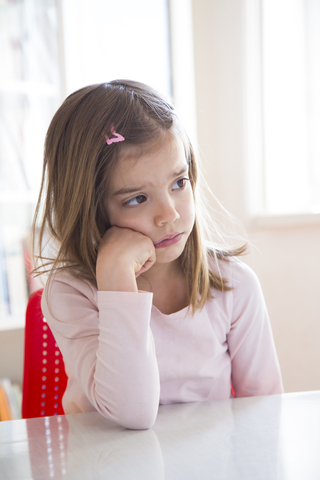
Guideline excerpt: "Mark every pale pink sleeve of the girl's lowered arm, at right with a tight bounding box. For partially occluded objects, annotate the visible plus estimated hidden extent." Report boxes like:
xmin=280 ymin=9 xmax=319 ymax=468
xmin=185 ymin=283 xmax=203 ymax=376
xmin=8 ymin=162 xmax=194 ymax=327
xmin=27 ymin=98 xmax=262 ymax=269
xmin=227 ymin=262 xmax=283 ymax=397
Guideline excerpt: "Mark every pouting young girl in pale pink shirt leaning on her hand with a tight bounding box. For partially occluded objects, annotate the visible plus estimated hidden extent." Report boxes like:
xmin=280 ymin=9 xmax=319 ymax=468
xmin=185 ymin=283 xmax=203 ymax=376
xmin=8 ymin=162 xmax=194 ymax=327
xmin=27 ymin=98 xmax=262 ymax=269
xmin=34 ymin=80 xmax=283 ymax=429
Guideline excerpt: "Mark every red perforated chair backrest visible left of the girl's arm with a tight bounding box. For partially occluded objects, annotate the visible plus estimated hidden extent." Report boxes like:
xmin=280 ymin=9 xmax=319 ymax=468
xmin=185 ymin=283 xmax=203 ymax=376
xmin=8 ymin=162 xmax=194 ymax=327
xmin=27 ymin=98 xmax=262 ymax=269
xmin=22 ymin=289 xmax=67 ymax=418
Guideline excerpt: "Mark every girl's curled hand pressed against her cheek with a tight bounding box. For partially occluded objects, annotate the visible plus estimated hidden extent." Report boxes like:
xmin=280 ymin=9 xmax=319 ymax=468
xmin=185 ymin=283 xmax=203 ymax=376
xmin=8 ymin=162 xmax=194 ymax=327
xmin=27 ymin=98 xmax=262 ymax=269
xmin=96 ymin=226 xmax=156 ymax=292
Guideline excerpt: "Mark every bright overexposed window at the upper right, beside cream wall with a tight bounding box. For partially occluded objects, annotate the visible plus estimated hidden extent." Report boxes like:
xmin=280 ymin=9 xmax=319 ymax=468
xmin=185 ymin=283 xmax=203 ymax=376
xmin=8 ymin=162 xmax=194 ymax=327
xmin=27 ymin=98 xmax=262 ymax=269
xmin=247 ymin=0 xmax=320 ymax=215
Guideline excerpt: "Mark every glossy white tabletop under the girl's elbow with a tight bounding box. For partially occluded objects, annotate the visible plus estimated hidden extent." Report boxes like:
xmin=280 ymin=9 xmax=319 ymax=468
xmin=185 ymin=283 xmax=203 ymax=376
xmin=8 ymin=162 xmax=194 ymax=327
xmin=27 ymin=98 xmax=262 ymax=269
xmin=0 ymin=391 xmax=320 ymax=480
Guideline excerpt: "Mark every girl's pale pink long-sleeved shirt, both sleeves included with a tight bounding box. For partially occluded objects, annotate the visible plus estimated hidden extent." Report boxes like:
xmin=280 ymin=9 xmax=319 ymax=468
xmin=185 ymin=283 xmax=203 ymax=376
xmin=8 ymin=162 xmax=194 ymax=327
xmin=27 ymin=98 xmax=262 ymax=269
xmin=42 ymin=260 xmax=283 ymax=428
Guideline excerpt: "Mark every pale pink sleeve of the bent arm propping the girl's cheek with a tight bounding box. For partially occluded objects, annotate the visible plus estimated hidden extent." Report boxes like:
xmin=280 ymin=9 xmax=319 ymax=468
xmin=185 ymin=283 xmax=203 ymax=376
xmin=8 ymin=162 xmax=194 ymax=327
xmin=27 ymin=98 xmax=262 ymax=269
xmin=42 ymin=272 xmax=160 ymax=429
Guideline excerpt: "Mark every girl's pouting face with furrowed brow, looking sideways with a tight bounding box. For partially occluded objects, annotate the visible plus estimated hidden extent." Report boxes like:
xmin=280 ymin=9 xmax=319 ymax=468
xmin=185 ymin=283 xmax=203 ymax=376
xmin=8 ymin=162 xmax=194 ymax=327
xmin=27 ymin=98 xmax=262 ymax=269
xmin=107 ymin=137 xmax=195 ymax=264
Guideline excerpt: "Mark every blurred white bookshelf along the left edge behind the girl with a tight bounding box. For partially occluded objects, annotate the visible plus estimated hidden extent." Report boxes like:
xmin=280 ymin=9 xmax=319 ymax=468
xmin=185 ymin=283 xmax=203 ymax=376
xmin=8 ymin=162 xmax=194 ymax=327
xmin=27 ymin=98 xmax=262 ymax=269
xmin=0 ymin=0 xmax=62 ymax=333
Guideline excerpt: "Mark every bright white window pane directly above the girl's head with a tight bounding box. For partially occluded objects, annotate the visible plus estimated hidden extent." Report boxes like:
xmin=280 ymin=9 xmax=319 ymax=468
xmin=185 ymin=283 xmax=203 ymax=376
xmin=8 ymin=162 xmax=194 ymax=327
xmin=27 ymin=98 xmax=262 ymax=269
xmin=61 ymin=0 xmax=171 ymax=96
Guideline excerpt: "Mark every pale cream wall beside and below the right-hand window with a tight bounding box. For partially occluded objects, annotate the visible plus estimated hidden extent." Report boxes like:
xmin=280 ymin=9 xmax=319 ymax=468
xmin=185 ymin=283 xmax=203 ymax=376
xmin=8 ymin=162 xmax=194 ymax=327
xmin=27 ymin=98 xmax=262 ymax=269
xmin=193 ymin=0 xmax=320 ymax=392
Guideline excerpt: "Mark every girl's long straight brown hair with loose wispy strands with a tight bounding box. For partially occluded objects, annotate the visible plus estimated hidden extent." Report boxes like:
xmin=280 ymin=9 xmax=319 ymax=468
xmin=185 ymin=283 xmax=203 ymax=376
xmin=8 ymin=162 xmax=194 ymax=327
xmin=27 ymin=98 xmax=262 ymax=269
xmin=33 ymin=80 xmax=245 ymax=312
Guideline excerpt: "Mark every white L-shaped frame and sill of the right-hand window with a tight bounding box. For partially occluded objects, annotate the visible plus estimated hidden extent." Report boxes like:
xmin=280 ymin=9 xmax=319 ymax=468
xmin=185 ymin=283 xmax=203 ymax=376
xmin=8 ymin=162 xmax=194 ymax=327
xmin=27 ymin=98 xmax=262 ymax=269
xmin=243 ymin=0 xmax=320 ymax=227
